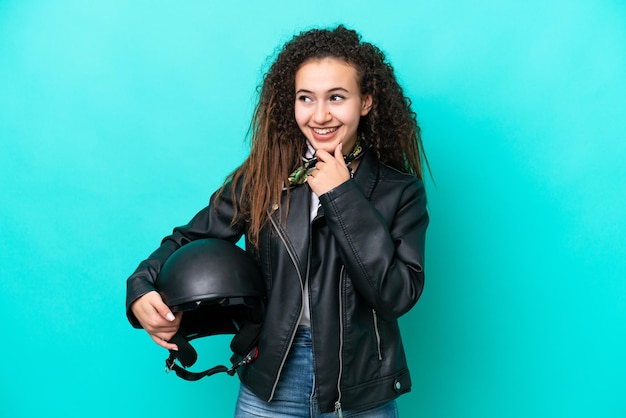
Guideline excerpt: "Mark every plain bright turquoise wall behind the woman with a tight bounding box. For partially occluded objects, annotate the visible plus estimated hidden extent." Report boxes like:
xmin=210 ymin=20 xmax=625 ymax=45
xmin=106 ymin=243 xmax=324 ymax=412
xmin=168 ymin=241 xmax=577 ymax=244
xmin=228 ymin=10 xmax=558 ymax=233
xmin=0 ymin=0 xmax=626 ymax=418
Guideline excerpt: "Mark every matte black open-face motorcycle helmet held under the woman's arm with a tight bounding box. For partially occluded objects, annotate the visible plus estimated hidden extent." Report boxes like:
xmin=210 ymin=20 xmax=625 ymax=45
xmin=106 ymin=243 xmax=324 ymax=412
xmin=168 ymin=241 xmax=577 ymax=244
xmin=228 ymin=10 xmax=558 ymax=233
xmin=155 ymin=238 xmax=265 ymax=380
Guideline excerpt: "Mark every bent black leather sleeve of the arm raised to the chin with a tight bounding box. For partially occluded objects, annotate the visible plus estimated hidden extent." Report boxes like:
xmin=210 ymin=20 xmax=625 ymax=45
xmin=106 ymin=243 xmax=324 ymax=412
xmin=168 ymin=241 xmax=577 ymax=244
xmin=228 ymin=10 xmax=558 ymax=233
xmin=320 ymin=173 xmax=429 ymax=319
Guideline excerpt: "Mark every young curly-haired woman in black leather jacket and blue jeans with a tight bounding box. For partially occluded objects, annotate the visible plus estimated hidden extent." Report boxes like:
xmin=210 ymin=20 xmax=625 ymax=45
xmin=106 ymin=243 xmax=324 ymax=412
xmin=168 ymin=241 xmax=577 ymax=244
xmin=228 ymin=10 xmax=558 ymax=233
xmin=127 ymin=26 xmax=428 ymax=417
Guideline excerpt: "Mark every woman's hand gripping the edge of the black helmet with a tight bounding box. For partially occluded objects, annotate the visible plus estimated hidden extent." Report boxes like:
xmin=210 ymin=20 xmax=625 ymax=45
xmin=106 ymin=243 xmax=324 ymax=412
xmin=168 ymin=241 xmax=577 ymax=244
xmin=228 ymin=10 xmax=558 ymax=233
xmin=130 ymin=290 xmax=183 ymax=350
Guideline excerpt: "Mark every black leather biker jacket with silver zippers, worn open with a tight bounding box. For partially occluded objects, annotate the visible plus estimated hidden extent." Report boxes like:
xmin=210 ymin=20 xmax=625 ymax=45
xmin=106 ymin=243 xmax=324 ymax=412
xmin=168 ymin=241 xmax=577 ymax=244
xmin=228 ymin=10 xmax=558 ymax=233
xmin=126 ymin=151 xmax=429 ymax=412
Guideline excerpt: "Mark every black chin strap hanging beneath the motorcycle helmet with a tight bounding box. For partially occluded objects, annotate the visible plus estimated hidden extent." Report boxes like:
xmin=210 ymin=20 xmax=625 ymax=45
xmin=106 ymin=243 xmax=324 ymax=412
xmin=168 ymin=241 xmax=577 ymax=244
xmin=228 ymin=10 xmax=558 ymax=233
xmin=165 ymin=323 xmax=261 ymax=381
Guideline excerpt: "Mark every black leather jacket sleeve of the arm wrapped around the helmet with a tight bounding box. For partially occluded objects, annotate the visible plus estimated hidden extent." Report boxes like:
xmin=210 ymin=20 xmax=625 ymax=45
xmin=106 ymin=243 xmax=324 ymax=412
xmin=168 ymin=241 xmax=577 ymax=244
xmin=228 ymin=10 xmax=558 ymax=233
xmin=126 ymin=186 xmax=244 ymax=328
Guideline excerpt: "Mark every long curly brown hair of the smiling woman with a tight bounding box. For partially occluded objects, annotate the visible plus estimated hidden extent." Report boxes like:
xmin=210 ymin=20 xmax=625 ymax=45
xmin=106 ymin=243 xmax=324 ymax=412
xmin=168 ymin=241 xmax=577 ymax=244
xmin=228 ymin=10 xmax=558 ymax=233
xmin=218 ymin=25 xmax=426 ymax=246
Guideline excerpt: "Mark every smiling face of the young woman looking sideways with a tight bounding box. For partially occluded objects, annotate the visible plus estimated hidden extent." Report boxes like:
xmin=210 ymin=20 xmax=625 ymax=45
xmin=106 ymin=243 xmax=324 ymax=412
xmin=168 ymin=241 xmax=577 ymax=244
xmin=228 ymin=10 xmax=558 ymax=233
xmin=295 ymin=58 xmax=372 ymax=154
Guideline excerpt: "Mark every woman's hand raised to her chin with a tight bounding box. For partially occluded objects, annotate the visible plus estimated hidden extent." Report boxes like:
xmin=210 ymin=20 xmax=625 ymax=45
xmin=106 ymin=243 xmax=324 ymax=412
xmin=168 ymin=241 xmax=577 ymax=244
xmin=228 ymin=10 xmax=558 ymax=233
xmin=306 ymin=143 xmax=350 ymax=196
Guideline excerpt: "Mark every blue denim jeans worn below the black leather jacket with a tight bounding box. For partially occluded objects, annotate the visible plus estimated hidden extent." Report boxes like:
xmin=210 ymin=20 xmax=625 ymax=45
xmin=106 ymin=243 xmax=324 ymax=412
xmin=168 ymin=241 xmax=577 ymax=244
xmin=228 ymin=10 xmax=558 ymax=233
xmin=235 ymin=328 xmax=398 ymax=418
